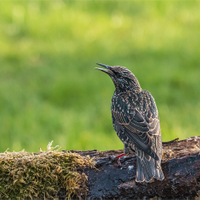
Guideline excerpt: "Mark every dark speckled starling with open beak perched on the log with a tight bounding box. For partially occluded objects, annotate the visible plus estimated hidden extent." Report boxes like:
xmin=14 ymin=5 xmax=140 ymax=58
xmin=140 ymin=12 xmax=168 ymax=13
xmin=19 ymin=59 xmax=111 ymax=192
xmin=95 ymin=63 xmax=164 ymax=182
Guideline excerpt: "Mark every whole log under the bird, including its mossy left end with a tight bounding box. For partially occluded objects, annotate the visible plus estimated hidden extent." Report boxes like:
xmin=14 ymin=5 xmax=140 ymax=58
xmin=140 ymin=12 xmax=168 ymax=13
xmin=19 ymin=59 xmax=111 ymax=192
xmin=0 ymin=136 xmax=200 ymax=199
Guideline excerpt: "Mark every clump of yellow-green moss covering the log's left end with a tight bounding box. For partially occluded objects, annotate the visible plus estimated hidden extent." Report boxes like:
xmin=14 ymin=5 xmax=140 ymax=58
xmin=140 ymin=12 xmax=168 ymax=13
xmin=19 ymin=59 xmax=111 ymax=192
xmin=0 ymin=145 xmax=94 ymax=199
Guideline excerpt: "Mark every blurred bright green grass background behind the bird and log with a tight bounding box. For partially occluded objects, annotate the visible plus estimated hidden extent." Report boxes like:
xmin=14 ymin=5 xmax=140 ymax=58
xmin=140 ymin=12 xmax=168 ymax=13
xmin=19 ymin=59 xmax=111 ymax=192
xmin=0 ymin=0 xmax=200 ymax=152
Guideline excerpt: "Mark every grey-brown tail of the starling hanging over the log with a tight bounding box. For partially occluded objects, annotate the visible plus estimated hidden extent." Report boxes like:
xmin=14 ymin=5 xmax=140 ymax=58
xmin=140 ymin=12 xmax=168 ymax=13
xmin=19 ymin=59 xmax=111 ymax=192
xmin=136 ymin=150 xmax=164 ymax=182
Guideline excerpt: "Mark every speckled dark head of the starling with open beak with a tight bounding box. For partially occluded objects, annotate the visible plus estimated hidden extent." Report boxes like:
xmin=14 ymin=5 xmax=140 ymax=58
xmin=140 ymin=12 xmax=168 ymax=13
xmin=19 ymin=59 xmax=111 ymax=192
xmin=95 ymin=63 xmax=142 ymax=92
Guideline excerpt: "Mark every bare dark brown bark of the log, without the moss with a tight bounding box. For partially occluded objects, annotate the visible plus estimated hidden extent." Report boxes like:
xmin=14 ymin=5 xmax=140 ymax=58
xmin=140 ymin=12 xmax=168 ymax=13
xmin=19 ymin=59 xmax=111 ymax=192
xmin=68 ymin=136 xmax=200 ymax=199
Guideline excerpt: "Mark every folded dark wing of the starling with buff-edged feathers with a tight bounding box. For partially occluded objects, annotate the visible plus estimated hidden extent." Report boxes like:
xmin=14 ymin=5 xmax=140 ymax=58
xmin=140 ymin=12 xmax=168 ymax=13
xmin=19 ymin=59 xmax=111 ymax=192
xmin=112 ymin=92 xmax=159 ymax=157
